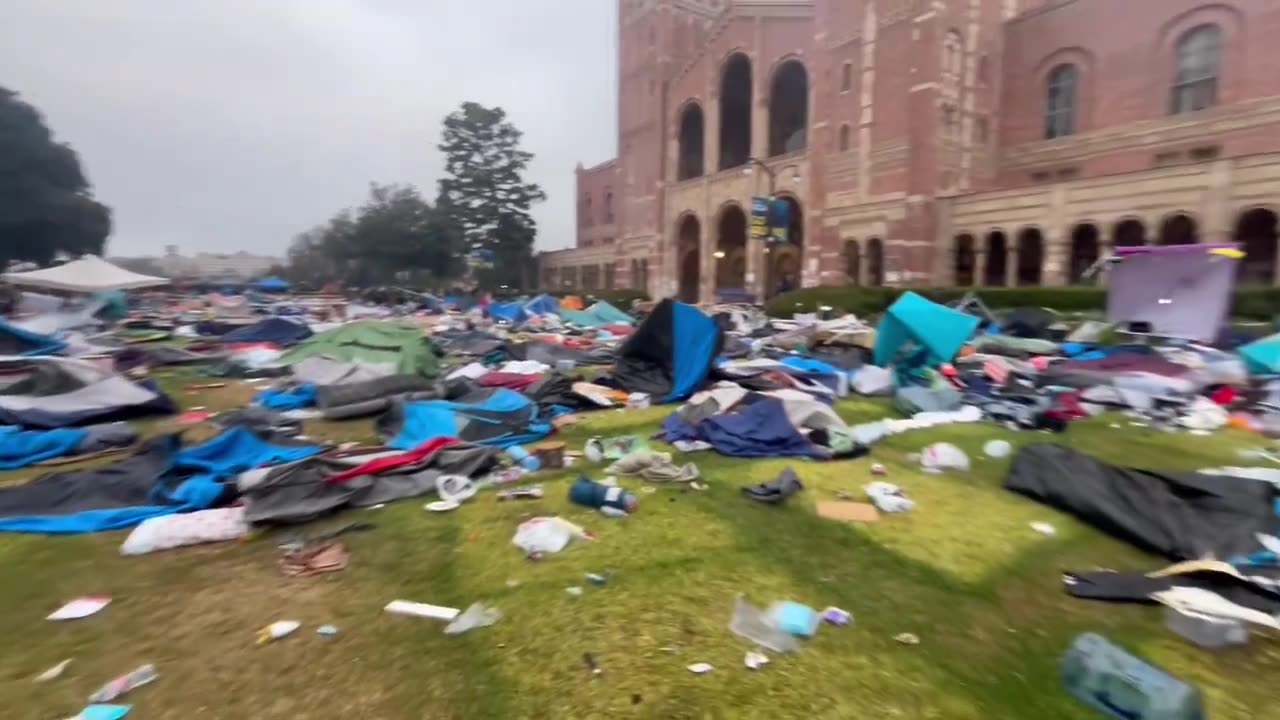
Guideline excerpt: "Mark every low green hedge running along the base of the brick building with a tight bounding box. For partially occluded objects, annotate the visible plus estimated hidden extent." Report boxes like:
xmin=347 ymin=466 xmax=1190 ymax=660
xmin=765 ymin=287 xmax=1280 ymax=320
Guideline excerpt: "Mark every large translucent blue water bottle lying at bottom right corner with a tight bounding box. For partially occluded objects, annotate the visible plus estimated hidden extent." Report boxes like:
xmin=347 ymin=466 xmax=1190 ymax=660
xmin=1060 ymin=633 xmax=1204 ymax=720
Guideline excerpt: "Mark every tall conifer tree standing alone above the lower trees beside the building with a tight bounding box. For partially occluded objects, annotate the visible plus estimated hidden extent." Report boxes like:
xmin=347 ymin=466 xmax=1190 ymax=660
xmin=436 ymin=102 xmax=547 ymax=287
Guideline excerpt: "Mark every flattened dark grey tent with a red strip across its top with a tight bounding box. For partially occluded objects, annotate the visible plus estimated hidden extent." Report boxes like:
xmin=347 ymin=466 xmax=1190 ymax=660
xmin=238 ymin=438 xmax=499 ymax=524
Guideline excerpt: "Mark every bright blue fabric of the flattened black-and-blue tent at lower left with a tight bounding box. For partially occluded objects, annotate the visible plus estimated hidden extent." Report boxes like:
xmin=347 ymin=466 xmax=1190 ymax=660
xmin=0 ymin=428 xmax=324 ymax=534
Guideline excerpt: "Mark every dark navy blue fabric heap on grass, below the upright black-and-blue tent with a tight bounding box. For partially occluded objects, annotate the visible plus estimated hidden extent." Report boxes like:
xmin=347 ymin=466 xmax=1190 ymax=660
xmin=662 ymin=397 xmax=826 ymax=459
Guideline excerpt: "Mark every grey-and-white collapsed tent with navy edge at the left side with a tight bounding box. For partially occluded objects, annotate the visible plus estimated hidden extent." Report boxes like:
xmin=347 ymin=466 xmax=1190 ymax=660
xmin=0 ymin=356 xmax=177 ymax=428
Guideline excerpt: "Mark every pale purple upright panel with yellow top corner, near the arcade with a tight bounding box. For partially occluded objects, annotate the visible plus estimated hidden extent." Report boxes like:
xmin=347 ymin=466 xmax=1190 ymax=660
xmin=1107 ymin=245 xmax=1239 ymax=341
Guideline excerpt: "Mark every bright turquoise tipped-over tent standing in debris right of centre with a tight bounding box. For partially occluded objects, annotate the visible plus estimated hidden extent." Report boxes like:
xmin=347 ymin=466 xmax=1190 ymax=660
xmin=874 ymin=292 xmax=982 ymax=368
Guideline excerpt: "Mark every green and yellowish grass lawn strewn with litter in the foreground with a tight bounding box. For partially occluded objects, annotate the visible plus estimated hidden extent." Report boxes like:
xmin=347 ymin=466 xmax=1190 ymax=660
xmin=0 ymin=378 xmax=1280 ymax=720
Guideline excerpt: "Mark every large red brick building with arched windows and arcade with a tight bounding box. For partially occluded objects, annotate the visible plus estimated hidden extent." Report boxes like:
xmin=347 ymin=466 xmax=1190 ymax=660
xmin=541 ymin=0 xmax=1280 ymax=300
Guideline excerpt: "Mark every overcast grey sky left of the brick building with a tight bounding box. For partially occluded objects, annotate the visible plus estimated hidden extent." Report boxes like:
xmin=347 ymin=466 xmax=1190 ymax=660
xmin=0 ymin=0 xmax=617 ymax=255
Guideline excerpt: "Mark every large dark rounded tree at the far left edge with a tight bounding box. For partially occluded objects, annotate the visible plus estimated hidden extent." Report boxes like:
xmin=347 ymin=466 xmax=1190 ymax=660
xmin=0 ymin=87 xmax=111 ymax=268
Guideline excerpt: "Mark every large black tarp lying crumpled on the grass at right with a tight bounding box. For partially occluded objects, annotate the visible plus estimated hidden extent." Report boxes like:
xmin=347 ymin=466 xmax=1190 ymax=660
xmin=1005 ymin=445 xmax=1280 ymax=560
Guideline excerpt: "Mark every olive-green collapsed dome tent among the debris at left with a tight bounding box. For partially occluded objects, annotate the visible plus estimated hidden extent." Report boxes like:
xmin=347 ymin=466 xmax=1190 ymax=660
xmin=280 ymin=320 xmax=440 ymax=378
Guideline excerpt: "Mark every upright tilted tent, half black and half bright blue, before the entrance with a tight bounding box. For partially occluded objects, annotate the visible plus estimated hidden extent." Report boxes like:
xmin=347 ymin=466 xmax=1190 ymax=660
xmin=613 ymin=299 xmax=724 ymax=402
